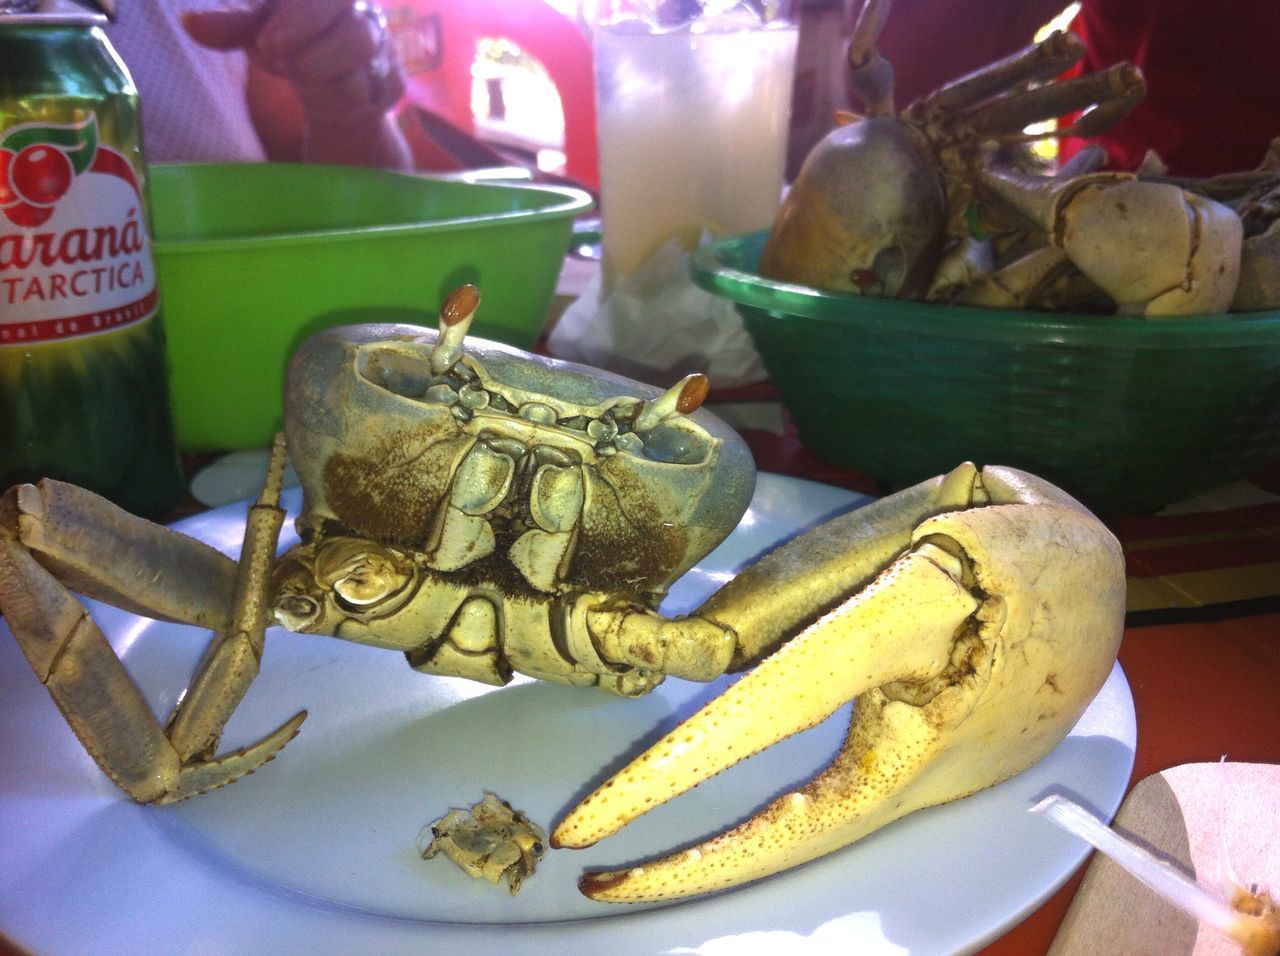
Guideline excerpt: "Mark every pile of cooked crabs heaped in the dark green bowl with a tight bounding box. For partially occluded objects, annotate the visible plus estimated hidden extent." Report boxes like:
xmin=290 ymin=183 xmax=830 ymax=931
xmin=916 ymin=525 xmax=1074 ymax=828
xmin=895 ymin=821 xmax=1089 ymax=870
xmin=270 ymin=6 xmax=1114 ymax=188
xmin=760 ymin=0 xmax=1280 ymax=316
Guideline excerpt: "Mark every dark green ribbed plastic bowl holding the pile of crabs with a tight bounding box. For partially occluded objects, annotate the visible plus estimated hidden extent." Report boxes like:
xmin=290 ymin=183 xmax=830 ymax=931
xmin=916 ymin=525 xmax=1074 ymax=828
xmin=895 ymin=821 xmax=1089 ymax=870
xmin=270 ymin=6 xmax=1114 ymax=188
xmin=694 ymin=233 xmax=1280 ymax=512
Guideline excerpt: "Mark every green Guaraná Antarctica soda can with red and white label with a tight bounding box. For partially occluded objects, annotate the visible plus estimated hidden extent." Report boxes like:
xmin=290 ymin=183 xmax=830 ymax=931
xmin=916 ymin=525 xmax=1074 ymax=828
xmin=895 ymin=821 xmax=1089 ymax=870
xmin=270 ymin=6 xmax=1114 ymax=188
xmin=0 ymin=0 xmax=183 ymax=517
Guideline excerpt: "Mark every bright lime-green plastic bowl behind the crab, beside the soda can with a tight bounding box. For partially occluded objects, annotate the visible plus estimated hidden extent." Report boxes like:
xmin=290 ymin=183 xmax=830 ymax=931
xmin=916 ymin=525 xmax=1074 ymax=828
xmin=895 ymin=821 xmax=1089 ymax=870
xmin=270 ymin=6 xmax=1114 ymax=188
xmin=150 ymin=164 xmax=591 ymax=450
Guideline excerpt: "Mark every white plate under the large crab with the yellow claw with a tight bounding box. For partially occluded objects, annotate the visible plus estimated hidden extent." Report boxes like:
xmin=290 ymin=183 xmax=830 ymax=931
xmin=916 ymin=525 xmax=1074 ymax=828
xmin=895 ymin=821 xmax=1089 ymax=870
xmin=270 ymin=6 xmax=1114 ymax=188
xmin=0 ymin=475 xmax=1135 ymax=956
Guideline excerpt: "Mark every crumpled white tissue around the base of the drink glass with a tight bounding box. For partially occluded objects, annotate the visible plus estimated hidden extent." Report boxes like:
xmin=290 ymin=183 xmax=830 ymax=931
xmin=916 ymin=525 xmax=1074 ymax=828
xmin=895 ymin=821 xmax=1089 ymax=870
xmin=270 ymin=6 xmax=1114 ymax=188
xmin=548 ymin=239 xmax=768 ymax=388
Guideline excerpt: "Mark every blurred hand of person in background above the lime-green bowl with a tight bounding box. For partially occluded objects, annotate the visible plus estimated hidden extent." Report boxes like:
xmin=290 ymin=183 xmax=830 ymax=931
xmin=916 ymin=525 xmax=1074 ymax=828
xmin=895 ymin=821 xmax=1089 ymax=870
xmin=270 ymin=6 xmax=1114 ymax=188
xmin=182 ymin=0 xmax=404 ymax=120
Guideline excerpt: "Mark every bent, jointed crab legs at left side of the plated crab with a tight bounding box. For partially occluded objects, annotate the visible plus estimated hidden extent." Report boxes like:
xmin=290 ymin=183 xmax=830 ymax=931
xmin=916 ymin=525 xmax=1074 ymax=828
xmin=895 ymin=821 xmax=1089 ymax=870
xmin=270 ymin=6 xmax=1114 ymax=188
xmin=0 ymin=437 xmax=305 ymax=802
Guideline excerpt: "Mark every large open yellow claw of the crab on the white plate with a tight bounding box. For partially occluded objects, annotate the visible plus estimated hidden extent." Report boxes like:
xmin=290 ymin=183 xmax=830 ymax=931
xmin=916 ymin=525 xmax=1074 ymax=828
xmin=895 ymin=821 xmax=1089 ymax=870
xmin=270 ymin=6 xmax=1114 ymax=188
xmin=552 ymin=465 xmax=1125 ymax=902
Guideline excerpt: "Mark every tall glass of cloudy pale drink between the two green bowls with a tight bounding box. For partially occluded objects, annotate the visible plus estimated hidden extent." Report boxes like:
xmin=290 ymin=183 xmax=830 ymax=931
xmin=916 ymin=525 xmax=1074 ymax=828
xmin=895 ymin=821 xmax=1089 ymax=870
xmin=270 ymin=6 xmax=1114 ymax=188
xmin=595 ymin=20 xmax=796 ymax=293
